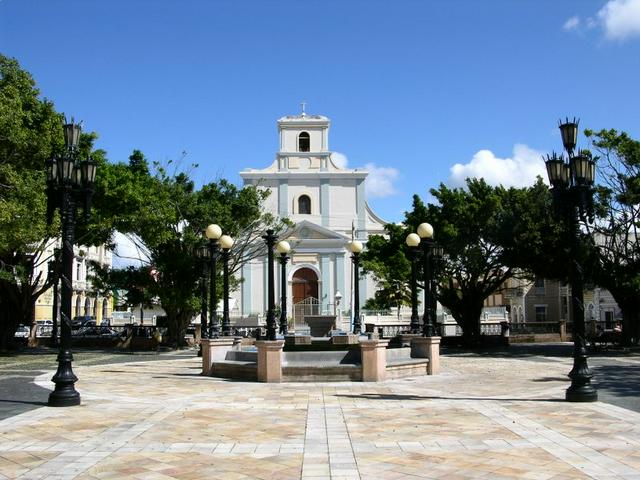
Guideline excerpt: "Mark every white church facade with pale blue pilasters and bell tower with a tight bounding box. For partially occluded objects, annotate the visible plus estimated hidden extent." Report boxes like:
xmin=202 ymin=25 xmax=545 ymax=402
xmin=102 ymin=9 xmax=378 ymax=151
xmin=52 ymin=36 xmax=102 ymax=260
xmin=234 ymin=110 xmax=385 ymax=324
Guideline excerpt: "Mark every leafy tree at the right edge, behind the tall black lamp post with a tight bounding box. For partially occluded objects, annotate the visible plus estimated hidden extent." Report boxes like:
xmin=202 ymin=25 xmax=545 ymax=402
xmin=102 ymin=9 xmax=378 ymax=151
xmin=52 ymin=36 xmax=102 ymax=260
xmin=585 ymin=130 xmax=640 ymax=344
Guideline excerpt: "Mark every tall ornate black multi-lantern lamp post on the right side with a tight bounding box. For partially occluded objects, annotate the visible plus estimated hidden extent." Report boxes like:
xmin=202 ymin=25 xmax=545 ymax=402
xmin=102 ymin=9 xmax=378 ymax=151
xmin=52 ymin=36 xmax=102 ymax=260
xmin=545 ymin=119 xmax=598 ymax=402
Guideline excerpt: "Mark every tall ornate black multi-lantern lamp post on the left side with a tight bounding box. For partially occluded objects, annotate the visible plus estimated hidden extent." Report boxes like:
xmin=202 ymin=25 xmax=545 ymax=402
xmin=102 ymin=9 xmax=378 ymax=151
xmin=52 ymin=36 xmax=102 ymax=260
xmin=47 ymin=122 xmax=96 ymax=407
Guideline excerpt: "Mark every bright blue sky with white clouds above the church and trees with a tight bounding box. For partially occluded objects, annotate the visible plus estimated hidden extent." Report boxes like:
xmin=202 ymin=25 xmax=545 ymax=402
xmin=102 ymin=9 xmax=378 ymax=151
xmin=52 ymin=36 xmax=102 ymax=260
xmin=0 ymin=0 xmax=640 ymax=221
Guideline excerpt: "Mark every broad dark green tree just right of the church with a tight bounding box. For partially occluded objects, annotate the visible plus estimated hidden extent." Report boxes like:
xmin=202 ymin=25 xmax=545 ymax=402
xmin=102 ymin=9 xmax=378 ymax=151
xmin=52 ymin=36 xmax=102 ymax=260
xmin=363 ymin=179 xmax=558 ymax=343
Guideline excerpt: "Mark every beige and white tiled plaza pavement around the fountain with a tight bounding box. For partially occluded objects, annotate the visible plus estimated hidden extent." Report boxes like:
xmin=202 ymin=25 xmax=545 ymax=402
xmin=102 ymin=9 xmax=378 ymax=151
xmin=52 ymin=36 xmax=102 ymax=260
xmin=0 ymin=346 xmax=640 ymax=480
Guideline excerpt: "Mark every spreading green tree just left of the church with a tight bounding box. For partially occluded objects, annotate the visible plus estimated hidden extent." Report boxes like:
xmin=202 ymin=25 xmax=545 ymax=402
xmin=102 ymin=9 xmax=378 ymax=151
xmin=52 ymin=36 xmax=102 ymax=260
xmin=89 ymin=151 xmax=283 ymax=346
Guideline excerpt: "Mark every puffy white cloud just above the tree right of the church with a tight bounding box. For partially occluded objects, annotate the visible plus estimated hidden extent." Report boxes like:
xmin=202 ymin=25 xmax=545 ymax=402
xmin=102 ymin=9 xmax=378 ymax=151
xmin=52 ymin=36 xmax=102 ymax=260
xmin=449 ymin=144 xmax=547 ymax=187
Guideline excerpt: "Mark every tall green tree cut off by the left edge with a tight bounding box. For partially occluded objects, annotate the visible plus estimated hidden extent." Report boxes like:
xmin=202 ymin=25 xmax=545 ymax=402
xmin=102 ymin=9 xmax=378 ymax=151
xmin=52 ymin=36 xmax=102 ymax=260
xmin=0 ymin=55 xmax=64 ymax=350
